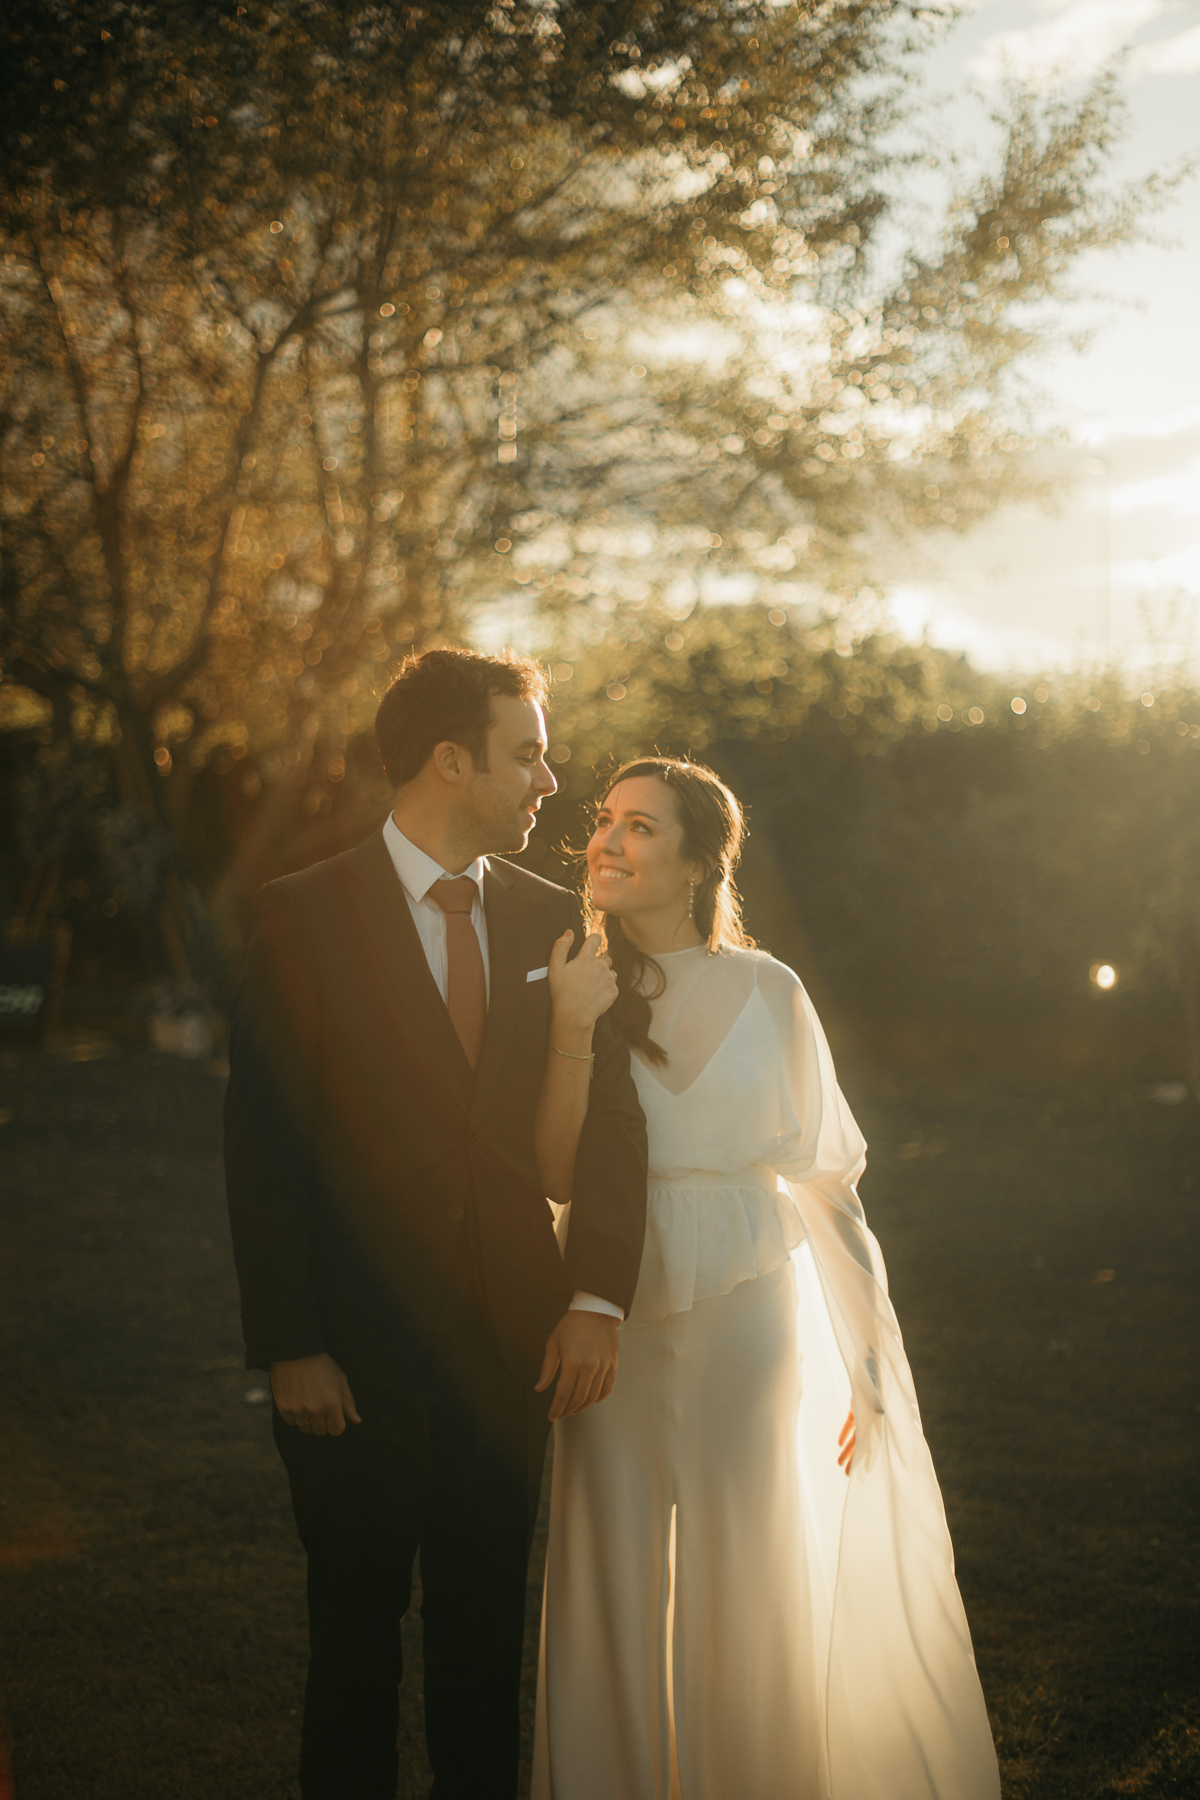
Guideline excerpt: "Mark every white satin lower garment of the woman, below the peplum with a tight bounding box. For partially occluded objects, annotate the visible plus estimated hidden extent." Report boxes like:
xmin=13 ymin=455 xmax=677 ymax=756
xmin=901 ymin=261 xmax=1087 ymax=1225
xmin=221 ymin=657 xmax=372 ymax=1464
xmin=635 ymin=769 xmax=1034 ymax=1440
xmin=533 ymin=1262 xmax=837 ymax=1800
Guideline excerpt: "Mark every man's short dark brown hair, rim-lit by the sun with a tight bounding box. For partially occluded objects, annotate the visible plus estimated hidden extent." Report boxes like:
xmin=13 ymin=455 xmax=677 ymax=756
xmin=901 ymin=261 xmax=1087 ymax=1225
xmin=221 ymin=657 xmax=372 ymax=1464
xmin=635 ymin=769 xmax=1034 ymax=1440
xmin=374 ymin=650 xmax=547 ymax=787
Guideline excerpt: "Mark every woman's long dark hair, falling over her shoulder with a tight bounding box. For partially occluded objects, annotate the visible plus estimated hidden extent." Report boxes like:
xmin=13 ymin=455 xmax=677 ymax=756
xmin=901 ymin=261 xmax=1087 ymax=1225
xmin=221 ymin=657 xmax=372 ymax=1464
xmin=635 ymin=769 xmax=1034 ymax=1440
xmin=588 ymin=756 xmax=754 ymax=1064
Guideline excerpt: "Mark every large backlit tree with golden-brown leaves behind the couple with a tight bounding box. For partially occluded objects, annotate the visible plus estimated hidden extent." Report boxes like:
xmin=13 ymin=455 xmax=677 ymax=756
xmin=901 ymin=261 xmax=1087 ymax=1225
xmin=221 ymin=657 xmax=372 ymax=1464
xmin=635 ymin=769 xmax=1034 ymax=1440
xmin=0 ymin=0 xmax=1153 ymax=957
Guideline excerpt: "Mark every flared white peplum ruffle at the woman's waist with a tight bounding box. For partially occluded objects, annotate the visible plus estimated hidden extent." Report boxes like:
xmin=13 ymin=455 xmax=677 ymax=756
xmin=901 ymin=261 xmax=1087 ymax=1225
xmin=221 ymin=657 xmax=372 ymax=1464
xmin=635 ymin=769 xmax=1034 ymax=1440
xmin=630 ymin=1168 xmax=804 ymax=1325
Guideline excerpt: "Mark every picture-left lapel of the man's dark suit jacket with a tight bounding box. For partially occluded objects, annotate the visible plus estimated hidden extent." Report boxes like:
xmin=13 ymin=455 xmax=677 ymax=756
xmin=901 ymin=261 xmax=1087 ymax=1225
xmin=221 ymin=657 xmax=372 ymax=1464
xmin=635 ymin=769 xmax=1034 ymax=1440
xmin=341 ymin=832 xmax=474 ymax=1107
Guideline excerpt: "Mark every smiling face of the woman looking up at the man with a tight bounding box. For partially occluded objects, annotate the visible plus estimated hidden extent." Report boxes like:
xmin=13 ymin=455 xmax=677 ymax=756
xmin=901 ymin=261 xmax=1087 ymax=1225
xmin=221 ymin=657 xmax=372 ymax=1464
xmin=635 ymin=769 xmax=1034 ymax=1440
xmin=588 ymin=776 xmax=698 ymax=918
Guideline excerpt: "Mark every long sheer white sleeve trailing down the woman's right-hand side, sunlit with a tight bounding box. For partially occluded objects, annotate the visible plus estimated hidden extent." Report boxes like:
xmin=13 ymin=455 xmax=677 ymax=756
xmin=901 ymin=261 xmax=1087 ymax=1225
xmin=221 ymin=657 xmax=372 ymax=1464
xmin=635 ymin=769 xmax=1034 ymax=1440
xmin=763 ymin=963 xmax=1000 ymax=1800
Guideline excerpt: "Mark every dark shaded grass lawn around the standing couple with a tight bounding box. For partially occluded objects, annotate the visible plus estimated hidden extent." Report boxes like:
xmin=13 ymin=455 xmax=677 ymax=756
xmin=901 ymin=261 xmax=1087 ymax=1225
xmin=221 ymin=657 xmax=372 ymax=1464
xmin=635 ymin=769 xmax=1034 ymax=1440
xmin=0 ymin=1051 xmax=1200 ymax=1800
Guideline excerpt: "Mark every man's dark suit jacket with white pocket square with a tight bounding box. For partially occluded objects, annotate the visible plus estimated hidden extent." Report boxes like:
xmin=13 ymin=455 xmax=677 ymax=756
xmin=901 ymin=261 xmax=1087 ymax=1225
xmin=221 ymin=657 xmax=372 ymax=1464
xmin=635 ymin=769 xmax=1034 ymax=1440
xmin=225 ymin=832 xmax=646 ymax=1386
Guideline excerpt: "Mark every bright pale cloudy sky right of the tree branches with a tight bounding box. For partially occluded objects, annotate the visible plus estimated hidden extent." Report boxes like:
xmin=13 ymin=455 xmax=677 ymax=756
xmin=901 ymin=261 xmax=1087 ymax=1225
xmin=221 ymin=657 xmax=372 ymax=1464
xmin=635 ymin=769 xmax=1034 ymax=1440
xmin=889 ymin=0 xmax=1200 ymax=673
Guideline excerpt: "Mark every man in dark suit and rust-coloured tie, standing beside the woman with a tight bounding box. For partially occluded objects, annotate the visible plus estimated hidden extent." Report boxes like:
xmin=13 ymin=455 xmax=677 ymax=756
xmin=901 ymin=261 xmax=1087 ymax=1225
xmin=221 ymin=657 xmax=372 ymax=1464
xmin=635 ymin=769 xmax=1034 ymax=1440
xmin=225 ymin=650 xmax=646 ymax=1800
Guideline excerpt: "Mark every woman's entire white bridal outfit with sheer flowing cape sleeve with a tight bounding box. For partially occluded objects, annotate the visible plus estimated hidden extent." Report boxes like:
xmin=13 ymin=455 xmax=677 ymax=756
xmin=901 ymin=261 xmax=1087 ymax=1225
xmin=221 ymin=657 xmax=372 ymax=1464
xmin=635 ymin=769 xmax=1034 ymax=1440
xmin=533 ymin=947 xmax=1000 ymax=1800
